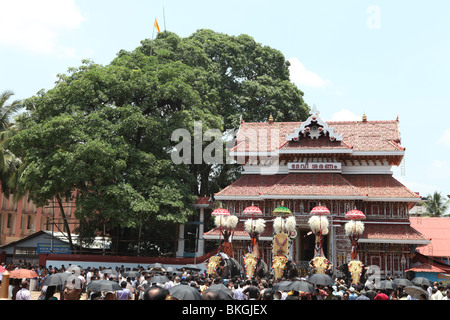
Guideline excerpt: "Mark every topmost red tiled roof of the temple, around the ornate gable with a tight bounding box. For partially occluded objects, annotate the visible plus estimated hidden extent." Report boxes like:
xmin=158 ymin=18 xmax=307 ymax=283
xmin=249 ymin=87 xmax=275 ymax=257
xmin=231 ymin=120 xmax=404 ymax=152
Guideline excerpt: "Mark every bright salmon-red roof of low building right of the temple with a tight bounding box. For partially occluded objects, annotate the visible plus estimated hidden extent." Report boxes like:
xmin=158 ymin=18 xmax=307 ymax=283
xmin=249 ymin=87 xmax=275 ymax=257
xmin=409 ymin=217 xmax=450 ymax=257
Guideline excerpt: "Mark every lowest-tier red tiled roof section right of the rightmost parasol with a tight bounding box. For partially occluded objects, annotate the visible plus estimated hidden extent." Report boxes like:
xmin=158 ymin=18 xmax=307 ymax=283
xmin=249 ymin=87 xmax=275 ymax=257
xmin=359 ymin=223 xmax=427 ymax=244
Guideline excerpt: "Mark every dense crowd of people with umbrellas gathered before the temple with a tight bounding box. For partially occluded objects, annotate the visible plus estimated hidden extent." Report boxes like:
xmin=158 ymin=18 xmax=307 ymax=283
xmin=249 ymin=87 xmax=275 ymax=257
xmin=4 ymin=265 xmax=450 ymax=300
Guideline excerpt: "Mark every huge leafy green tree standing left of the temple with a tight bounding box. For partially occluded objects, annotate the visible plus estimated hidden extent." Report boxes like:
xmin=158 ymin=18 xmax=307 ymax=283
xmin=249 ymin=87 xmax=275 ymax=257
xmin=10 ymin=30 xmax=308 ymax=253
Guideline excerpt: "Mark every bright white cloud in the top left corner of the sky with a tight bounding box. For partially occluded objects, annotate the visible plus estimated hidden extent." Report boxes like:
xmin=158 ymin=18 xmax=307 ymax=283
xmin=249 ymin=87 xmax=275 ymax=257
xmin=0 ymin=0 xmax=85 ymax=57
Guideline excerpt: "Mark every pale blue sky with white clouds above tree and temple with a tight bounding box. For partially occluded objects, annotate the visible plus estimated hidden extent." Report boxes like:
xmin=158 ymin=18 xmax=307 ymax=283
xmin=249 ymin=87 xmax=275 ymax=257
xmin=0 ymin=0 xmax=450 ymax=196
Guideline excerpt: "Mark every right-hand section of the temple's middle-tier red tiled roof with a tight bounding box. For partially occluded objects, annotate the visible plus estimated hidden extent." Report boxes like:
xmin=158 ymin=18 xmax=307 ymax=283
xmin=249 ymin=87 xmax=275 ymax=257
xmin=344 ymin=174 xmax=420 ymax=198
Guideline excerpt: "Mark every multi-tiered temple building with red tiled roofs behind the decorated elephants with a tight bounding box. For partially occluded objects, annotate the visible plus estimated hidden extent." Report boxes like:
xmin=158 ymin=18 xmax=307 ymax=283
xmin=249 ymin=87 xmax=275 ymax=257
xmin=204 ymin=107 xmax=430 ymax=276
